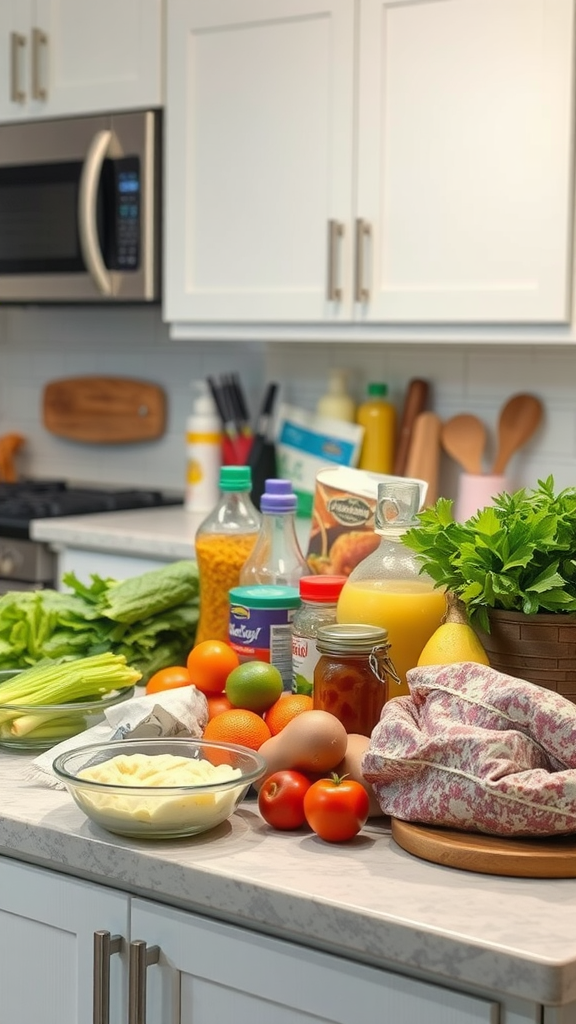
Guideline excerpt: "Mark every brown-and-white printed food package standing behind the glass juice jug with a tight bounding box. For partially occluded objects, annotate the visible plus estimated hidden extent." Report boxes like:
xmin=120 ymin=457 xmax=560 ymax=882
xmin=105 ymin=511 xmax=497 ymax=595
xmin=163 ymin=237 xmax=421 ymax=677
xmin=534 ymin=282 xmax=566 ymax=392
xmin=306 ymin=467 xmax=426 ymax=575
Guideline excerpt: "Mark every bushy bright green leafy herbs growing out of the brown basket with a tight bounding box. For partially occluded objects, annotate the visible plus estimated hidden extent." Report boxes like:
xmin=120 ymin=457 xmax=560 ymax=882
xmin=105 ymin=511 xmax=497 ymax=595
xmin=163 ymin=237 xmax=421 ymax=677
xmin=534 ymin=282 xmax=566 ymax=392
xmin=402 ymin=476 xmax=576 ymax=632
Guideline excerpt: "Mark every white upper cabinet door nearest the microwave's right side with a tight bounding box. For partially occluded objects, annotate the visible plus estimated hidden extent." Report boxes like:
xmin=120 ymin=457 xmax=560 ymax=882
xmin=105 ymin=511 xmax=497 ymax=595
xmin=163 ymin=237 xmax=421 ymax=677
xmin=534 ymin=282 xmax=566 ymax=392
xmin=164 ymin=0 xmax=355 ymax=322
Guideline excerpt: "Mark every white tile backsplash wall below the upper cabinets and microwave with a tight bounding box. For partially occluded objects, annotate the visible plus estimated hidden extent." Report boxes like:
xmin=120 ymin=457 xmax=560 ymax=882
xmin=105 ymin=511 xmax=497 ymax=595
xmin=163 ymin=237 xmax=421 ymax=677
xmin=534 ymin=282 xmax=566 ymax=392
xmin=0 ymin=306 xmax=576 ymax=497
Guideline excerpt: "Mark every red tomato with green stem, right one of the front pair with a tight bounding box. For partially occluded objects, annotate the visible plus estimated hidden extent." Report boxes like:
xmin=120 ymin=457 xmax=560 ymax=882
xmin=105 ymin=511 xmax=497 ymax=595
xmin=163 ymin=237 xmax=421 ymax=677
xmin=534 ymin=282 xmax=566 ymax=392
xmin=304 ymin=774 xmax=370 ymax=843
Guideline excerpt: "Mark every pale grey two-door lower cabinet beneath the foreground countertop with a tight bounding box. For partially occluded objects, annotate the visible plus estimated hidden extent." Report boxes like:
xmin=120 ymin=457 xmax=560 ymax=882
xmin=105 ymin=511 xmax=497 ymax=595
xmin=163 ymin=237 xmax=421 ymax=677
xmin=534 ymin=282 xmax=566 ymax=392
xmin=0 ymin=858 xmax=502 ymax=1024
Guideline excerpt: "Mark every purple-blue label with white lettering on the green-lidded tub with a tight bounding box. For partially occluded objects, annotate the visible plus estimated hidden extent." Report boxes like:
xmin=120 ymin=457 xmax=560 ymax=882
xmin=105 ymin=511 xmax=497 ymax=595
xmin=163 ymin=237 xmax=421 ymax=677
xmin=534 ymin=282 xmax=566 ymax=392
xmin=229 ymin=604 xmax=294 ymax=690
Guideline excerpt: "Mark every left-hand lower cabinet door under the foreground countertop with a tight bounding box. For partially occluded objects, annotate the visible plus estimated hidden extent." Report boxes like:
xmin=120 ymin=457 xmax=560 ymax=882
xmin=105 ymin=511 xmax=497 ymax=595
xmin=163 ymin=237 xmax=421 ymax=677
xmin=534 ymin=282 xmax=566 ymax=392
xmin=0 ymin=858 xmax=129 ymax=1024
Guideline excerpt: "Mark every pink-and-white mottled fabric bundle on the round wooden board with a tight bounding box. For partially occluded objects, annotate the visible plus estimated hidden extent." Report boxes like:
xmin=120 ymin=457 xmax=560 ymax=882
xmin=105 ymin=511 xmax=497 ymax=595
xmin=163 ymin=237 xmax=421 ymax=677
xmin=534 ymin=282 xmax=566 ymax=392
xmin=362 ymin=662 xmax=576 ymax=836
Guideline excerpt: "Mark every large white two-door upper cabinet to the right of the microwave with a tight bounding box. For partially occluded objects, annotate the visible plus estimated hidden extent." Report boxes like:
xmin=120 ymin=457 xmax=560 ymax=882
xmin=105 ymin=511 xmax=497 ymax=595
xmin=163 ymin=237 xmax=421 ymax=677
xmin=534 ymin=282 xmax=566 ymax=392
xmin=164 ymin=0 xmax=575 ymax=326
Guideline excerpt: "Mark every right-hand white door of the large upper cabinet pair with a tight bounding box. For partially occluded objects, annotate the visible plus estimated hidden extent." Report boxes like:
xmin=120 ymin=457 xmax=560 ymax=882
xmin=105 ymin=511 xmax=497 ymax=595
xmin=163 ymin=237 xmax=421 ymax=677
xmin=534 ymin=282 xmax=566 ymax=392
xmin=356 ymin=0 xmax=574 ymax=323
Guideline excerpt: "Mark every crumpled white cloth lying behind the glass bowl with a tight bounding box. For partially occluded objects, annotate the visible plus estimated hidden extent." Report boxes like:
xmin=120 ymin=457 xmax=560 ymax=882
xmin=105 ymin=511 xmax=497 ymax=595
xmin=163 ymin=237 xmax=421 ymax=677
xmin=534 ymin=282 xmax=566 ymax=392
xmin=26 ymin=686 xmax=208 ymax=790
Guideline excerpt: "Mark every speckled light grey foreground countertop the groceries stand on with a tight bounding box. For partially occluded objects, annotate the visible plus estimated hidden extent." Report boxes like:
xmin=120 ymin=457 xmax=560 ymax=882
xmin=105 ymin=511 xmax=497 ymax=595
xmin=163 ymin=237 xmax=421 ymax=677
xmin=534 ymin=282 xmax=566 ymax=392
xmin=0 ymin=753 xmax=576 ymax=1005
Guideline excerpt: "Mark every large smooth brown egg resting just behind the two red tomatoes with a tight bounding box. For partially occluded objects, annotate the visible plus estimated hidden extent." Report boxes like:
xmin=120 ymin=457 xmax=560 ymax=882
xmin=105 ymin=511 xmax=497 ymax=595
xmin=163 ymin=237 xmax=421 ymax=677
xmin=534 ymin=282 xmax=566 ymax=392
xmin=254 ymin=711 xmax=348 ymax=790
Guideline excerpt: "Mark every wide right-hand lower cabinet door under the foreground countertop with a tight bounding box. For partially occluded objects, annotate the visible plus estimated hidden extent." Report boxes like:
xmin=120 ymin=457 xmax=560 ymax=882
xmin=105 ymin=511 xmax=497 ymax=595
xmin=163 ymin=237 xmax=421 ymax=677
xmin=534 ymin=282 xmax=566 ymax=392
xmin=131 ymin=900 xmax=499 ymax=1024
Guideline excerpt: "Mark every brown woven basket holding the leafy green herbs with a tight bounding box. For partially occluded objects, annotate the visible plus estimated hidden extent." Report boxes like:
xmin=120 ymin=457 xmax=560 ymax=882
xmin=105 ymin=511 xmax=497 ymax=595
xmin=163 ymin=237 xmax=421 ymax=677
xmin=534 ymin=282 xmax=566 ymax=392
xmin=477 ymin=608 xmax=576 ymax=703
